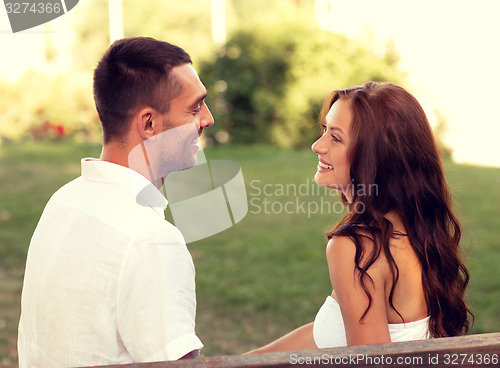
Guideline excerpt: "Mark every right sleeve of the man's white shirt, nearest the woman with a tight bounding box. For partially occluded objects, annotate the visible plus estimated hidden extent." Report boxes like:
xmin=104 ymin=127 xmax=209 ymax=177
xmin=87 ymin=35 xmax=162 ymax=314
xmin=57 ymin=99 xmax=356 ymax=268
xmin=117 ymin=224 xmax=203 ymax=362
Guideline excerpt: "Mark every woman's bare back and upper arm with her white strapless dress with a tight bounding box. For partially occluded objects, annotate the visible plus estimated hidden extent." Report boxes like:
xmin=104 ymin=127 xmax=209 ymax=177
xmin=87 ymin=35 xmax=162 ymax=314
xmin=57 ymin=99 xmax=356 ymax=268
xmin=320 ymin=213 xmax=430 ymax=346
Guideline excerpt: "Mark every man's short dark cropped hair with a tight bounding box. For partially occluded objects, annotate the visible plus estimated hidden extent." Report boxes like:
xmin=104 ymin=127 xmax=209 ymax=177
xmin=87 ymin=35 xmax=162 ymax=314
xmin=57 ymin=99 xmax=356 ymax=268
xmin=94 ymin=37 xmax=192 ymax=143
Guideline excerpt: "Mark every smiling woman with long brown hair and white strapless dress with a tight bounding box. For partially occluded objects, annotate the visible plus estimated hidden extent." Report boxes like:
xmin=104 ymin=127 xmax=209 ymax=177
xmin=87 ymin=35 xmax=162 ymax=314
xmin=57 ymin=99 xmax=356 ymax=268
xmin=252 ymin=83 xmax=472 ymax=353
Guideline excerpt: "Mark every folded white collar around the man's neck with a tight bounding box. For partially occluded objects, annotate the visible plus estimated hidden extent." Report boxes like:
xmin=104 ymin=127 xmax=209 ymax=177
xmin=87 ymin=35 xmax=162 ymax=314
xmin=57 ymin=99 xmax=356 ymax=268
xmin=82 ymin=158 xmax=168 ymax=217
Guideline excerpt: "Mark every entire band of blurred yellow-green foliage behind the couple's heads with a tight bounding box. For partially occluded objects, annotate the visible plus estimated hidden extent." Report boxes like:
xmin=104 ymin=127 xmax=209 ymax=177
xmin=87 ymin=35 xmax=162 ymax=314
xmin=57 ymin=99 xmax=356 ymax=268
xmin=0 ymin=0 xmax=404 ymax=147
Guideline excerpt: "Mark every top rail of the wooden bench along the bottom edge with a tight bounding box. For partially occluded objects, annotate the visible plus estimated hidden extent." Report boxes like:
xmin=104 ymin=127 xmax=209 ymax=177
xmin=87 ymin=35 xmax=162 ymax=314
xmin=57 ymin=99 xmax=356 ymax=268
xmin=93 ymin=332 xmax=500 ymax=368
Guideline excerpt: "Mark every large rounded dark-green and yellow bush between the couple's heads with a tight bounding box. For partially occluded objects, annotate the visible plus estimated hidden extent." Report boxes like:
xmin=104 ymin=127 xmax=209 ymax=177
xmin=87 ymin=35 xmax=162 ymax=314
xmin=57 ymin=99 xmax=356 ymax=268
xmin=200 ymin=21 xmax=402 ymax=147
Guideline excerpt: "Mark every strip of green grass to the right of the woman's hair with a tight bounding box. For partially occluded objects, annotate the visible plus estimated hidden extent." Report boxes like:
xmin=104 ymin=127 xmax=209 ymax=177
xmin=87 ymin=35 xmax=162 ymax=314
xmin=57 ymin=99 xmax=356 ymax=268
xmin=447 ymin=165 xmax=500 ymax=333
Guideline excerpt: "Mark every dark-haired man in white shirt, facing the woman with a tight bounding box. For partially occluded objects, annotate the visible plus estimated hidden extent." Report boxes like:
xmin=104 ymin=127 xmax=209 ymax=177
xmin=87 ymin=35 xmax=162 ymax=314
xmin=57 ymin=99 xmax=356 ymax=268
xmin=18 ymin=37 xmax=213 ymax=367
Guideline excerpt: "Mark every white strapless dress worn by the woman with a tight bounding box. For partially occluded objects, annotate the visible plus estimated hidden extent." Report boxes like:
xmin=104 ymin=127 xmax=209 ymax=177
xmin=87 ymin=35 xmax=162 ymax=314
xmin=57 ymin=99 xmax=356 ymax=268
xmin=313 ymin=296 xmax=431 ymax=348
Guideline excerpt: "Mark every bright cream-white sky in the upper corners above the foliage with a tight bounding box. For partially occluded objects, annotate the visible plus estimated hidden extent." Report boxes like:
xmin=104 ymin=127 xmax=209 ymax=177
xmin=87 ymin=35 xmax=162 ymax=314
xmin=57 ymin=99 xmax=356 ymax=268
xmin=0 ymin=0 xmax=500 ymax=167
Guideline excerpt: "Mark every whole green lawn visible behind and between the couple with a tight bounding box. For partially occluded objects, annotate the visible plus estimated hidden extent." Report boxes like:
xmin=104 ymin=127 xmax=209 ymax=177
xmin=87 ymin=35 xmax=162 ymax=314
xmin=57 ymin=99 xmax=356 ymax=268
xmin=0 ymin=142 xmax=500 ymax=367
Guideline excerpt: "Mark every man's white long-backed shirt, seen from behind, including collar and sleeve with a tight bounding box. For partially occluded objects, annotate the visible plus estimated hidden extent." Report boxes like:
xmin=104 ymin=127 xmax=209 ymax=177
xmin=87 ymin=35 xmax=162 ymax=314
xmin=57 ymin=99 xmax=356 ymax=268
xmin=18 ymin=159 xmax=203 ymax=368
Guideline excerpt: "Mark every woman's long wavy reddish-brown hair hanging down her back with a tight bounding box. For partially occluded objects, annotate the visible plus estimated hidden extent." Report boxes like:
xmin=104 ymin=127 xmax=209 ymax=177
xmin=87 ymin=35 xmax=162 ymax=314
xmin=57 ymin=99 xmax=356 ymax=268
xmin=320 ymin=82 xmax=472 ymax=337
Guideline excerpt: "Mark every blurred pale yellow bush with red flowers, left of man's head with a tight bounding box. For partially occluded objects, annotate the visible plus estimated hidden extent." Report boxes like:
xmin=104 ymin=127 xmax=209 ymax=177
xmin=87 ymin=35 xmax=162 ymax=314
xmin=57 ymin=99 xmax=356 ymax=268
xmin=0 ymin=71 xmax=100 ymax=142
